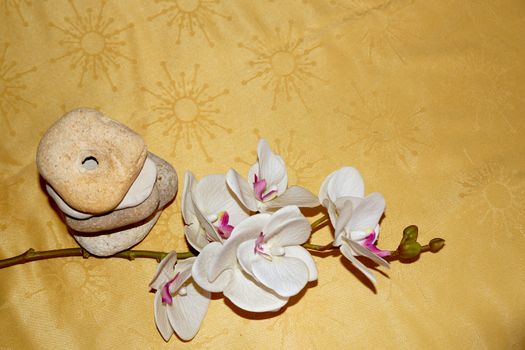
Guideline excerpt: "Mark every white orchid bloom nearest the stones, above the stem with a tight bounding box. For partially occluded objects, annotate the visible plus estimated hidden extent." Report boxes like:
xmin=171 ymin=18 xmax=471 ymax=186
xmin=182 ymin=171 xmax=248 ymax=251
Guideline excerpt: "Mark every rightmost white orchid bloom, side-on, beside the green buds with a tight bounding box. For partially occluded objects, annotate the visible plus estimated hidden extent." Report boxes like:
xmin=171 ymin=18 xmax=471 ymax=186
xmin=319 ymin=167 xmax=390 ymax=284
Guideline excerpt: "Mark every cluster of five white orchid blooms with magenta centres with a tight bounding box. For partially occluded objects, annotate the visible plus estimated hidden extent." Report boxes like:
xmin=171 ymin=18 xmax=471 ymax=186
xmin=150 ymin=139 xmax=398 ymax=341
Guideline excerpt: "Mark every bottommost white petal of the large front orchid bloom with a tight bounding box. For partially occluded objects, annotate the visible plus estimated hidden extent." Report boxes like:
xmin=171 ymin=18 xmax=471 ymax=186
xmin=224 ymin=268 xmax=288 ymax=312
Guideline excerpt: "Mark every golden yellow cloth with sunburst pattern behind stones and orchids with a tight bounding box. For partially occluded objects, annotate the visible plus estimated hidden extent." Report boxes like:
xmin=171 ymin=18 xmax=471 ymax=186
xmin=0 ymin=0 xmax=525 ymax=349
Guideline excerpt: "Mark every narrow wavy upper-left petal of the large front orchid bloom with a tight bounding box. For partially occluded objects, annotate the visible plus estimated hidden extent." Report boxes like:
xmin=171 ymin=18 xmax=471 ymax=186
xmin=208 ymin=214 xmax=270 ymax=281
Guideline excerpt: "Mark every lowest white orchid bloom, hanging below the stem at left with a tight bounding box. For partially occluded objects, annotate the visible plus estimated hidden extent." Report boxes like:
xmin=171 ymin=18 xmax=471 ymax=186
xmin=150 ymin=252 xmax=210 ymax=341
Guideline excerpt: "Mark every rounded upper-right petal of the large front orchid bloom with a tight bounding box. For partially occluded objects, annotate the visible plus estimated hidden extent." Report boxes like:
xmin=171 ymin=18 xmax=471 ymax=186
xmin=263 ymin=205 xmax=312 ymax=247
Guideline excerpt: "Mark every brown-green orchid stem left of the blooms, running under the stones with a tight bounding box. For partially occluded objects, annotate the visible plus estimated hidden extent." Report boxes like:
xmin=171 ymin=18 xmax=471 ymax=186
xmin=0 ymin=248 xmax=195 ymax=269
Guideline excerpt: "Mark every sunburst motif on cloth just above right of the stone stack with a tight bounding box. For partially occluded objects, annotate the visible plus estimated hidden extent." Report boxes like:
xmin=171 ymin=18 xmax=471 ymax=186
xmin=142 ymin=62 xmax=232 ymax=162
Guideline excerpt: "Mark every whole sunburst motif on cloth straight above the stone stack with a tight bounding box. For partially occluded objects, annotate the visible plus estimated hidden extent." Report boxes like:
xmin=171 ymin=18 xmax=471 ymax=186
xmin=50 ymin=0 xmax=136 ymax=91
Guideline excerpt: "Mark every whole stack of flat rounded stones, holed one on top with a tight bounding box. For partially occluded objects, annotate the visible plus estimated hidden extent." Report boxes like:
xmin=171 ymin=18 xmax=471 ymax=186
xmin=37 ymin=108 xmax=177 ymax=256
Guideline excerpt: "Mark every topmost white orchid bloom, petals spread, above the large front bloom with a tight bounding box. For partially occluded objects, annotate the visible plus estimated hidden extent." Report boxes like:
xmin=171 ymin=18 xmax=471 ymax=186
xmin=226 ymin=139 xmax=319 ymax=212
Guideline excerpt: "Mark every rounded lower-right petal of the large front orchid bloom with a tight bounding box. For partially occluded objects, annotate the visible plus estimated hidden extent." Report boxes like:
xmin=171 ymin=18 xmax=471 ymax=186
xmin=252 ymin=255 xmax=309 ymax=297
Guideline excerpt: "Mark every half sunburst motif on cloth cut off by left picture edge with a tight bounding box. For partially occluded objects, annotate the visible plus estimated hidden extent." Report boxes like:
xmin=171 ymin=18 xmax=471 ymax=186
xmin=0 ymin=44 xmax=36 ymax=136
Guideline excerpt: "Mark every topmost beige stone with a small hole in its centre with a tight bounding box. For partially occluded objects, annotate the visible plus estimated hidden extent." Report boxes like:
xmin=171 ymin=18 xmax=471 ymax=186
xmin=37 ymin=108 xmax=147 ymax=215
